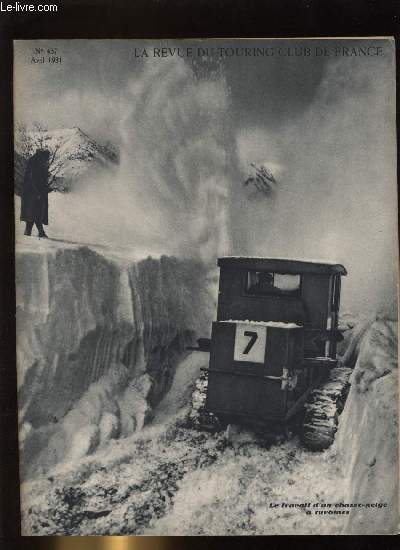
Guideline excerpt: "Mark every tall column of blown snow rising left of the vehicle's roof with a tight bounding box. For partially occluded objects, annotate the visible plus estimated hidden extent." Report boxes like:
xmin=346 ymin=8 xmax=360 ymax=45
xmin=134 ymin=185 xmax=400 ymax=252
xmin=120 ymin=59 xmax=233 ymax=261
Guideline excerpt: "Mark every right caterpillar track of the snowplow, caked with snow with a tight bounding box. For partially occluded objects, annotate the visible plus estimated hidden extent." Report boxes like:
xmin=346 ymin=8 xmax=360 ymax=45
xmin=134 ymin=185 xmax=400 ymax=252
xmin=302 ymin=367 xmax=353 ymax=451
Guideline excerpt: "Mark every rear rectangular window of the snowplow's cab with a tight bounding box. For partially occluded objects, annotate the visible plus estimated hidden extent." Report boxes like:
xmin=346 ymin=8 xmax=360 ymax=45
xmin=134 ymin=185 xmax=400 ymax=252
xmin=245 ymin=271 xmax=301 ymax=296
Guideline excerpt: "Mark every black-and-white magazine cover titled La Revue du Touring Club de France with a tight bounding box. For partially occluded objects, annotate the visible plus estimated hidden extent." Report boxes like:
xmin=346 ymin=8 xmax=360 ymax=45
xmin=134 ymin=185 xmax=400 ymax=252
xmin=14 ymin=37 xmax=398 ymax=535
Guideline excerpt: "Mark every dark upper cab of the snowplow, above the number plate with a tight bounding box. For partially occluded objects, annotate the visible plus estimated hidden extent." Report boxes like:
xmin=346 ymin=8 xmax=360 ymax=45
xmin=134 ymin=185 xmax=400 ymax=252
xmin=217 ymin=257 xmax=347 ymax=358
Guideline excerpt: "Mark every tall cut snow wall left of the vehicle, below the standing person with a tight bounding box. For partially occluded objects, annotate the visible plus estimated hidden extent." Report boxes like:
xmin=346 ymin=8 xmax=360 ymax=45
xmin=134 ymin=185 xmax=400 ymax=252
xmin=16 ymin=242 xmax=213 ymax=476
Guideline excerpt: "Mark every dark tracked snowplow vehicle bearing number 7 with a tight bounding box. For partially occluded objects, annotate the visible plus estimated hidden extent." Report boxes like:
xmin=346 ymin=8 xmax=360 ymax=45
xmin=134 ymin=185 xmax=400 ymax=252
xmin=190 ymin=257 xmax=352 ymax=450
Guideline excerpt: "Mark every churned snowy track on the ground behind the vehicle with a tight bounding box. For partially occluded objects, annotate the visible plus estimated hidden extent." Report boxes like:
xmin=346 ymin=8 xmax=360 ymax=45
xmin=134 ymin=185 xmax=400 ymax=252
xmin=18 ymin=353 xmax=348 ymax=535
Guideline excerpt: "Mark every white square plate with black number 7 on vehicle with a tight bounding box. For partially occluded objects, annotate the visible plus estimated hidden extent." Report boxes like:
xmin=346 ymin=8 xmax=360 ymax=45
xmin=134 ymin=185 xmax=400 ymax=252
xmin=233 ymin=323 xmax=267 ymax=363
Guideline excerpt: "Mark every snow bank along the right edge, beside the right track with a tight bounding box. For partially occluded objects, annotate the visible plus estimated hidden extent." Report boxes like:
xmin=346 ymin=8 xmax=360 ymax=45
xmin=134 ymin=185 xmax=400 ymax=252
xmin=334 ymin=320 xmax=399 ymax=534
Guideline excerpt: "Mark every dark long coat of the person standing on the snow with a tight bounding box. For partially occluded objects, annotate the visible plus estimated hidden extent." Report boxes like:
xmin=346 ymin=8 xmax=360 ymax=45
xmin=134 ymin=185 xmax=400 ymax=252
xmin=21 ymin=152 xmax=49 ymax=225
